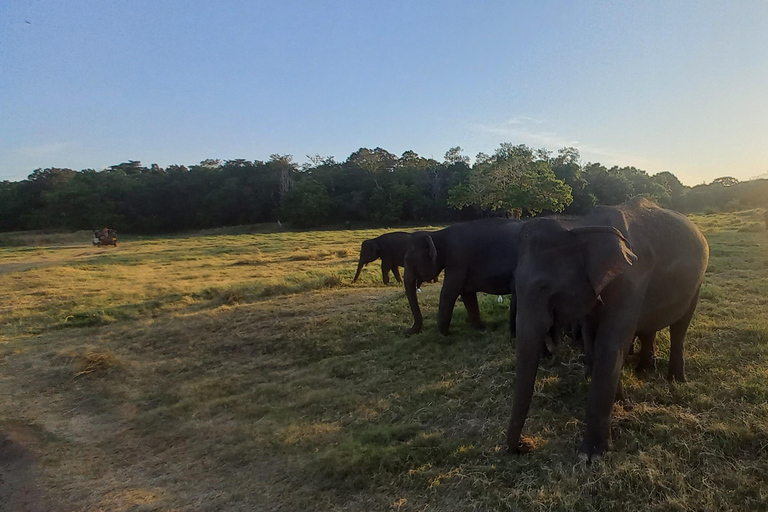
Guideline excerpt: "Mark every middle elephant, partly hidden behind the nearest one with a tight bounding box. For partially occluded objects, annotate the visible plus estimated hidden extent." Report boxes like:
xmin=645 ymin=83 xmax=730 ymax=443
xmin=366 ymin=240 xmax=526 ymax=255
xmin=405 ymin=218 xmax=523 ymax=334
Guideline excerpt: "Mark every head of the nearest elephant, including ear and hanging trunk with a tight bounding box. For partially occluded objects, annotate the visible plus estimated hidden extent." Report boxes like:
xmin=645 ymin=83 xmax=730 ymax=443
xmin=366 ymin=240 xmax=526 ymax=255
xmin=507 ymin=219 xmax=637 ymax=451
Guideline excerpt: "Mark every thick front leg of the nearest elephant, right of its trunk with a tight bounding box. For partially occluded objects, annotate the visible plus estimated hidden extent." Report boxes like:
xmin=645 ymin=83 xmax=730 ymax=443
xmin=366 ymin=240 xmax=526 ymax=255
xmin=579 ymin=326 xmax=634 ymax=460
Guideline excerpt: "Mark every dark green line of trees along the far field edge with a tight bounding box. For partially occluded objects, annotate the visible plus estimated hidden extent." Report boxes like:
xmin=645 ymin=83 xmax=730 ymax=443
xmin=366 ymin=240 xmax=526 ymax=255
xmin=0 ymin=143 xmax=768 ymax=233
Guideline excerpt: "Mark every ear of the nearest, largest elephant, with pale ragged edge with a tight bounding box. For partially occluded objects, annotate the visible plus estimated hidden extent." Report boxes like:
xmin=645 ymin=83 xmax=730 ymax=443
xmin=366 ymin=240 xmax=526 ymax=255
xmin=571 ymin=226 xmax=637 ymax=295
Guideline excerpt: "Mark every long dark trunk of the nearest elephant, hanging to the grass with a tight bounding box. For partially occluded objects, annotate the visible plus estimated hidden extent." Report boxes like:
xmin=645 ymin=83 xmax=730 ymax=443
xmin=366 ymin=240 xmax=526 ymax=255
xmin=507 ymin=308 xmax=548 ymax=453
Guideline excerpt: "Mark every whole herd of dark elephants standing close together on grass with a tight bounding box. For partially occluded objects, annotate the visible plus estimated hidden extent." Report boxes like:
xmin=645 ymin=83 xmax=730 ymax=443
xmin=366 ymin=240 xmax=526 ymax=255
xmin=355 ymin=198 xmax=709 ymax=461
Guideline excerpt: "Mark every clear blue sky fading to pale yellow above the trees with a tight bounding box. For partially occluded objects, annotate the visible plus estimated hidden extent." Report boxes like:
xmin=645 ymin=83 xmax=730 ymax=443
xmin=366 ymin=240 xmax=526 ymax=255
xmin=0 ymin=0 xmax=768 ymax=185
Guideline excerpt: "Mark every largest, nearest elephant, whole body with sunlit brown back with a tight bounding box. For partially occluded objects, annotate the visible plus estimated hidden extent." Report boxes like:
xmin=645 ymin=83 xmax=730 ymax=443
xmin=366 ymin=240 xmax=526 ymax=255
xmin=507 ymin=199 xmax=709 ymax=461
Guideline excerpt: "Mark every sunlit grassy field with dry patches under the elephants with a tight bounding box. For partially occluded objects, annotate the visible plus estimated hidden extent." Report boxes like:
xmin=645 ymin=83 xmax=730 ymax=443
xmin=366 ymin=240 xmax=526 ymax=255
xmin=0 ymin=210 xmax=768 ymax=511
